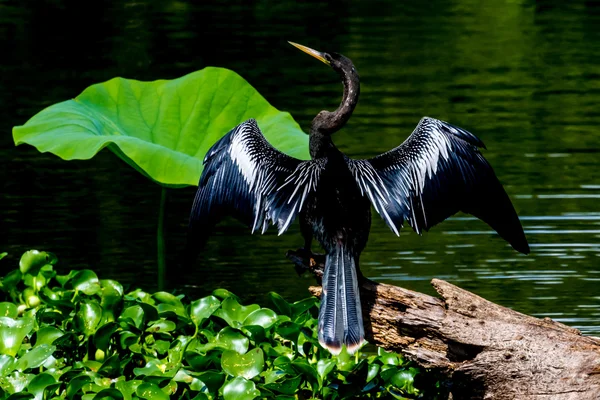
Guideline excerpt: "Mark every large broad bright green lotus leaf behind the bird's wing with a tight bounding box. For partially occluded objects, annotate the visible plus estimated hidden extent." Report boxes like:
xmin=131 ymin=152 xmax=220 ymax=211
xmin=13 ymin=67 xmax=308 ymax=186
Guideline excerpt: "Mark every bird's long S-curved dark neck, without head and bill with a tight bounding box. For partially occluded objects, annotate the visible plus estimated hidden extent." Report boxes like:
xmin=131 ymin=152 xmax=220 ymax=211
xmin=310 ymin=60 xmax=360 ymax=158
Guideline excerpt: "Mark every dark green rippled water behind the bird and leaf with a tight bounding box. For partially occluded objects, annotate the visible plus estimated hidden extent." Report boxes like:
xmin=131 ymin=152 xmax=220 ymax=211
xmin=0 ymin=0 xmax=600 ymax=335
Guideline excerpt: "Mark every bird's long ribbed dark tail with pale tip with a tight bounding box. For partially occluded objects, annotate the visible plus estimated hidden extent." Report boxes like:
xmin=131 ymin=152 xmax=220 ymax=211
xmin=319 ymin=245 xmax=365 ymax=355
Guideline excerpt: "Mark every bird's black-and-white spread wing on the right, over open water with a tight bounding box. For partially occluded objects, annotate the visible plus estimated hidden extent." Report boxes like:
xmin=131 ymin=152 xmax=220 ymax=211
xmin=348 ymin=117 xmax=529 ymax=254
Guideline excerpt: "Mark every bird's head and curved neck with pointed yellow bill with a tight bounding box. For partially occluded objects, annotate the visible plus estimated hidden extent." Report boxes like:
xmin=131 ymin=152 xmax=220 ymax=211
xmin=289 ymin=42 xmax=360 ymax=135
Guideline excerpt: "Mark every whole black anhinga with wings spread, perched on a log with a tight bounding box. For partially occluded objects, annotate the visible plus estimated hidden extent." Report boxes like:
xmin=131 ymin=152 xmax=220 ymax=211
xmin=190 ymin=42 xmax=529 ymax=354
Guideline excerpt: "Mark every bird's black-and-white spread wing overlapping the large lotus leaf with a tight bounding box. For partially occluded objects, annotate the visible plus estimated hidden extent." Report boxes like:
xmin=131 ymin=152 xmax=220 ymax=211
xmin=188 ymin=119 xmax=326 ymax=258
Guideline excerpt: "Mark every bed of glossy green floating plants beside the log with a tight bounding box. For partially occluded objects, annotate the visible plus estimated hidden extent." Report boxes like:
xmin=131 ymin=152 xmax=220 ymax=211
xmin=0 ymin=250 xmax=444 ymax=400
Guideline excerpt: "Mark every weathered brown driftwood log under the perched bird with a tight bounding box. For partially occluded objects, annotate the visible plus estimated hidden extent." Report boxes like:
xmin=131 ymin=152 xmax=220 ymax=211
xmin=288 ymin=251 xmax=600 ymax=400
